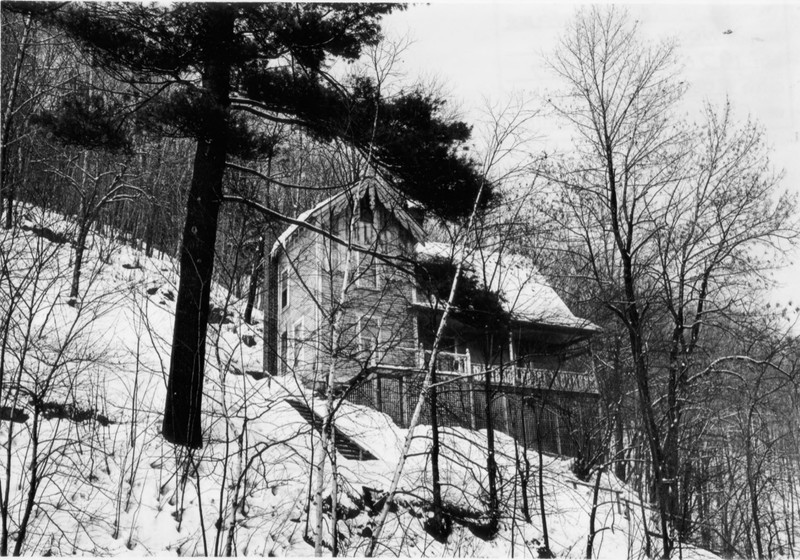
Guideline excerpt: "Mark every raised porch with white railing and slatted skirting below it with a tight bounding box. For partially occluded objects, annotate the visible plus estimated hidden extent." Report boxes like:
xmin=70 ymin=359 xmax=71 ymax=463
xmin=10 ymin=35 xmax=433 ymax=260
xmin=348 ymin=351 xmax=599 ymax=457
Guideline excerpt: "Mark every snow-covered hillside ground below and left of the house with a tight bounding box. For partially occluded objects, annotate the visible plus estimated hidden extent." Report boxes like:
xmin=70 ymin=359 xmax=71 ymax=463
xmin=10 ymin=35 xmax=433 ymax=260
xmin=0 ymin=210 xmax=713 ymax=558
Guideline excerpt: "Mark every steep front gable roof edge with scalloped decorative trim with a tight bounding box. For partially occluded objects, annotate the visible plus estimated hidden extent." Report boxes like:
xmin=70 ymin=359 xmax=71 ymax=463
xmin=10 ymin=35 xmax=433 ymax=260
xmin=270 ymin=178 xmax=425 ymax=257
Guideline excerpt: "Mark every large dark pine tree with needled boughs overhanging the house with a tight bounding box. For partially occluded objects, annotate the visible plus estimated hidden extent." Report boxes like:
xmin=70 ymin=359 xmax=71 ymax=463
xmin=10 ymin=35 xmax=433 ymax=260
xmin=36 ymin=3 xmax=490 ymax=447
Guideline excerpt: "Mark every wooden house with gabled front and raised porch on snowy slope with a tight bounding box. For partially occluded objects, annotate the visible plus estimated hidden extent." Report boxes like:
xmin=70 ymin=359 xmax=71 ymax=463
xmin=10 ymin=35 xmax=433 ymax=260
xmin=266 ymin=180 xmax=598 ymax=455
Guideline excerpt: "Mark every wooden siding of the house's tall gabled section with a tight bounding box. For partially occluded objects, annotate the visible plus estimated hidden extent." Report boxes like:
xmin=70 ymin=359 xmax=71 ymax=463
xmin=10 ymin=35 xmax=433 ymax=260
xmin=273 ymin=195 xmax=414 ymax=386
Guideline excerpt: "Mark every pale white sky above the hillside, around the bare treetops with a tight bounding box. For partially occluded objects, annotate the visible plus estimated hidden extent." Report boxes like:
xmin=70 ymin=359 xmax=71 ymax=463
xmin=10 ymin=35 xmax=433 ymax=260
xmin=383 ymin=1 xmax=800 ymax=320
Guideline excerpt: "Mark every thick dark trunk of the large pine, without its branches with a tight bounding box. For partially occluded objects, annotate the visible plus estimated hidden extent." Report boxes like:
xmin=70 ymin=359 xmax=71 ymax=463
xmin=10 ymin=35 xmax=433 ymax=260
xmin=162 ymin=6 xmax=233 ymax=448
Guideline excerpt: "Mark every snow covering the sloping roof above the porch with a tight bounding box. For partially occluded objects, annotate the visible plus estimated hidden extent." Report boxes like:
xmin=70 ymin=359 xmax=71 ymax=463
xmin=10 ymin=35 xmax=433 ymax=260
xmin=414 ymin=242 xmax=600 ymax=331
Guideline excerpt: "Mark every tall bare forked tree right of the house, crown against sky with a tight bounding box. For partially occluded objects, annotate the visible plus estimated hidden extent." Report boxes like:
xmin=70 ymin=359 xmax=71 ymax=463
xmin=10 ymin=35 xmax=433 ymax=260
xmin=548 ymin=8 xmax=796 ymax=556
